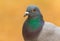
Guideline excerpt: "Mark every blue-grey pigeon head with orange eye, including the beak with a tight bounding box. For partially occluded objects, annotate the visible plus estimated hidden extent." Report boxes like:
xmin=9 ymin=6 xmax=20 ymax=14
xmin=24 ymin=5 xmax=41 ymax=17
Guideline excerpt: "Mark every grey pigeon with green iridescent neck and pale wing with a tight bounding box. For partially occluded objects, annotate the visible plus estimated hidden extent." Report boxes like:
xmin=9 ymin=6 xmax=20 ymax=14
xmin=22 ymin=5 xmax=60 ymax=41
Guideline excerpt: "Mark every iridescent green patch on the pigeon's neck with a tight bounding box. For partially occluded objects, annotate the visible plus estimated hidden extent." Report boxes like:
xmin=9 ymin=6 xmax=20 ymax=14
xmin=28 ymin=17 xmax=43 ymax=31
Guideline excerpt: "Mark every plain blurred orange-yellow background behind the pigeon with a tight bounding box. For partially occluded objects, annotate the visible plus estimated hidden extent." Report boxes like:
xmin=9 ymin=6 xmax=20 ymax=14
xmin=0 ymin=0 xmax=60 ymax=41
